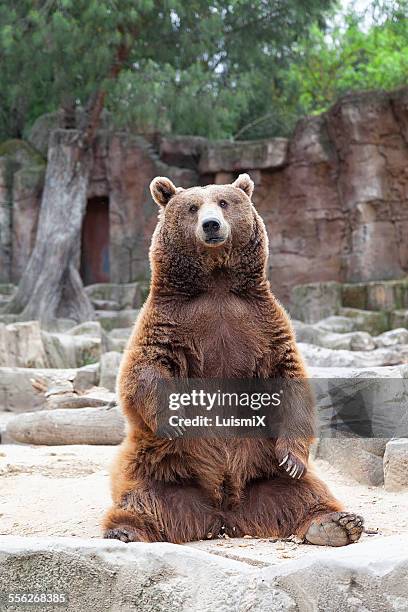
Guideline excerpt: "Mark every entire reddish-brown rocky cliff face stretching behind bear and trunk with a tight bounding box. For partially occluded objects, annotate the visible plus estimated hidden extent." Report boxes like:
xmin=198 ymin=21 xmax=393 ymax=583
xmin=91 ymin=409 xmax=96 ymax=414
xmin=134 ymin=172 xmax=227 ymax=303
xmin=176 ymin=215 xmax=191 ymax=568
xmin=0 ymin=88 xmax=408 ymax=303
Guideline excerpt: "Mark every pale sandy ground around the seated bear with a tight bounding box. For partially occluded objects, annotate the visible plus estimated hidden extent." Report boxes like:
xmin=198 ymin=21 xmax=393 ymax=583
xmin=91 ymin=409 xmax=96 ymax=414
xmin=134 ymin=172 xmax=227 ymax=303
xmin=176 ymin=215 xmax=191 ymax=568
xmin=0 ymin=444 xmax=408 ymax=565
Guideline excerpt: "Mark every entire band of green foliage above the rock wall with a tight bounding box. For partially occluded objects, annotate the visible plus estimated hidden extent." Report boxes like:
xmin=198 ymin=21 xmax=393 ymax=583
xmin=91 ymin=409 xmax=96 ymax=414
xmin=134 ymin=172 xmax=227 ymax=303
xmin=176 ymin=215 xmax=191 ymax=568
xmin=0 ymin=0 xmax=408 ymax=140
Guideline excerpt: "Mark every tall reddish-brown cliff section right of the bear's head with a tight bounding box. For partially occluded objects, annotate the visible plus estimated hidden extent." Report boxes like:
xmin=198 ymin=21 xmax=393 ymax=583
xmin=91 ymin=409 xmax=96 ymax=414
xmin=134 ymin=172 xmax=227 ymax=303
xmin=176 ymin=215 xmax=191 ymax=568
xmin=256 ymin=89 xmax=408 ymax=300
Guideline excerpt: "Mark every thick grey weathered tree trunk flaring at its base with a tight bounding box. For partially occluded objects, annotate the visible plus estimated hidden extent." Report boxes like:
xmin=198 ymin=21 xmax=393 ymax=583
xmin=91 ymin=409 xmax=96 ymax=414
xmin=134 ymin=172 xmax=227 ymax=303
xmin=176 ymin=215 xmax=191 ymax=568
xmin=6 ymin=130 xmax=94 ymax=324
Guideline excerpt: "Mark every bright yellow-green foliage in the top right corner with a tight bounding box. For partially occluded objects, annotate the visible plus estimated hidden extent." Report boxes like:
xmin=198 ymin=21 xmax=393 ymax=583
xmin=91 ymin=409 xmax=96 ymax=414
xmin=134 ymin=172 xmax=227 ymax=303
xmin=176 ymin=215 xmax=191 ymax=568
xmin=288 ymin=1 xmax=408 ymax=113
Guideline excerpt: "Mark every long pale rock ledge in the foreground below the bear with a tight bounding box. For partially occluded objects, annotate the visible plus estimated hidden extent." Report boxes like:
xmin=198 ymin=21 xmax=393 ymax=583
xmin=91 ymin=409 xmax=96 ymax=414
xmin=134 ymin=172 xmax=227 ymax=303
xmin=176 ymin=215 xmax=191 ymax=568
xmin=0 ymin=536 xmax=408 ymax=612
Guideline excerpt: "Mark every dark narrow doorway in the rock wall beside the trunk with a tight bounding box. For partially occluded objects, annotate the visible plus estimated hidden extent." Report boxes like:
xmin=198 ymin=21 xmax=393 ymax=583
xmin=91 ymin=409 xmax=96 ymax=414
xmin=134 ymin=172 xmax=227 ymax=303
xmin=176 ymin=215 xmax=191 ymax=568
xmin=81 ymin=197 xmax=110 ymax=285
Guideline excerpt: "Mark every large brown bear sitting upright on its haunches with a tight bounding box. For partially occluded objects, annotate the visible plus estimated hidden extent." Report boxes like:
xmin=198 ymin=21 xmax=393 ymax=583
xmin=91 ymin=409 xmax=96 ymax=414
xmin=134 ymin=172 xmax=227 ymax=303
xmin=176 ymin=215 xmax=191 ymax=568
xmin=103 ymin=174 xmax=363 ymax=546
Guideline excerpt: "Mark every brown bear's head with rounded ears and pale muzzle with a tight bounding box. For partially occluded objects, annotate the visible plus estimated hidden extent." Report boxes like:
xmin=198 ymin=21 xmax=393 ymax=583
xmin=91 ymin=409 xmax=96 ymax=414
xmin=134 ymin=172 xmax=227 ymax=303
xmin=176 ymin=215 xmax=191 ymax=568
xmin=150 ymin=174 xmax=268 ymax=293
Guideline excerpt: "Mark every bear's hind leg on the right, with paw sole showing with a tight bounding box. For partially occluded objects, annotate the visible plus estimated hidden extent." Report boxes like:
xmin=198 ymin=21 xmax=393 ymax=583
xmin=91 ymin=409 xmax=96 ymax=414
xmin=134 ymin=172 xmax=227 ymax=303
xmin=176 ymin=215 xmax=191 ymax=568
xmin=225 ymin=471 xmax=363 ymax=546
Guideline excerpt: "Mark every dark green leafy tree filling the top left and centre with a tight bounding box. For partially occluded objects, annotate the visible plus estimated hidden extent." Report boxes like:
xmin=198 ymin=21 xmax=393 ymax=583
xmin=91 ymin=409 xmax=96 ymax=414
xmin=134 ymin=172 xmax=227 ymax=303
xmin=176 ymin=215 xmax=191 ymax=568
xmin=0 ymin=0 xmax=333 ymax=140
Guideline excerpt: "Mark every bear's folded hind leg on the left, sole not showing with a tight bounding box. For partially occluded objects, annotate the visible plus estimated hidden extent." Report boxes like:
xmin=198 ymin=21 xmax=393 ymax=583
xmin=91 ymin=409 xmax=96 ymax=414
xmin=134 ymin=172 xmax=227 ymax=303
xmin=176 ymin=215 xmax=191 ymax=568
xmin=103 ymin=482 xmax=223 ymax=544
